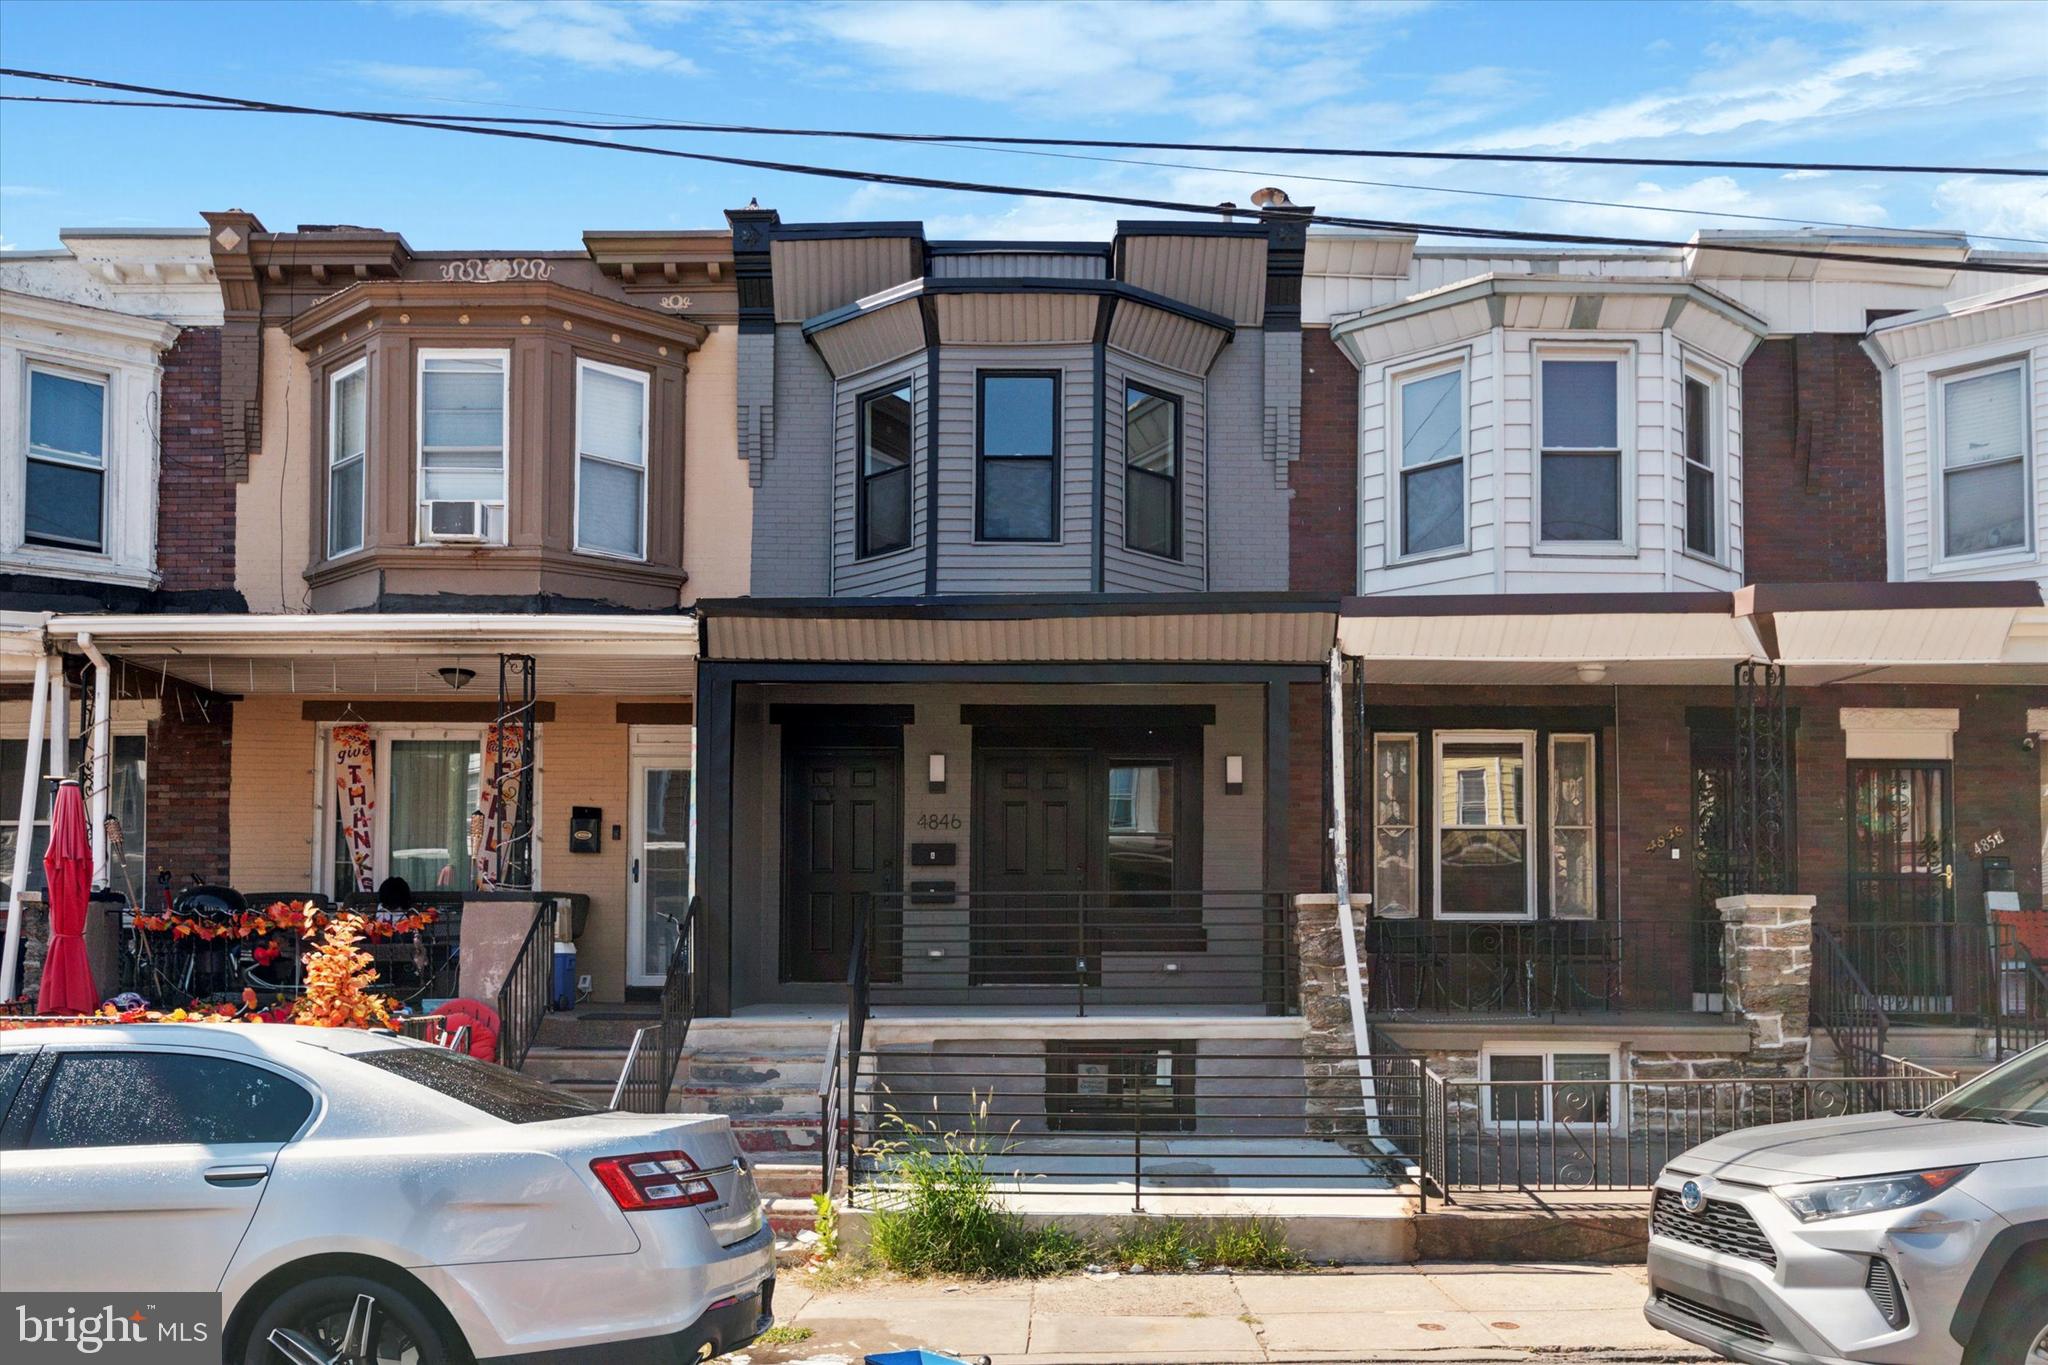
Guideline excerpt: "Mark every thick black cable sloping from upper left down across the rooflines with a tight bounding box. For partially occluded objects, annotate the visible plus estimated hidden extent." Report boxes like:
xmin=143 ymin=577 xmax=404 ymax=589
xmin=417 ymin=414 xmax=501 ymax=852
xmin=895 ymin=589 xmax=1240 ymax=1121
xmin=12 ymin=68 xmax=2048 ymax=276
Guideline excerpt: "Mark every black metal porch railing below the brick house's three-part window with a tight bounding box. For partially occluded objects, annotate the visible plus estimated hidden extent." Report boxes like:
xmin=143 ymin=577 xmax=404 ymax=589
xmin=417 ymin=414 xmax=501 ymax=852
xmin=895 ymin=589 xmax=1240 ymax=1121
xmin=1366 ymin=919 xmax=1720 ymax=1017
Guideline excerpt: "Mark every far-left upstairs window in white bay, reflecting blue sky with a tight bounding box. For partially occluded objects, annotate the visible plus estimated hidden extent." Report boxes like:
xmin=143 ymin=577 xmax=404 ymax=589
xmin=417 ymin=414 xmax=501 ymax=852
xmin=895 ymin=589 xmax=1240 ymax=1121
xmin=23 ymin=366 xmax=106 ymax=553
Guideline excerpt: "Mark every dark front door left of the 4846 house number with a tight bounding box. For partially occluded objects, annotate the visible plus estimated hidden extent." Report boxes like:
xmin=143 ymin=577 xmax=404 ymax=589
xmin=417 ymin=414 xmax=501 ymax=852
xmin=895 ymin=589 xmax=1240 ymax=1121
xmin=782 ymin=745 xmax=903 ymax=982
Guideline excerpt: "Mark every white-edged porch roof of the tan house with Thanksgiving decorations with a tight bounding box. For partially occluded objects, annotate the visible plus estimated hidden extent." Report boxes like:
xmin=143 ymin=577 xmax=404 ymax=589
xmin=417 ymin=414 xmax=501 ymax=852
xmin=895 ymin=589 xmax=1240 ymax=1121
xmin=45 ymin=612 xmax=696 ymax=698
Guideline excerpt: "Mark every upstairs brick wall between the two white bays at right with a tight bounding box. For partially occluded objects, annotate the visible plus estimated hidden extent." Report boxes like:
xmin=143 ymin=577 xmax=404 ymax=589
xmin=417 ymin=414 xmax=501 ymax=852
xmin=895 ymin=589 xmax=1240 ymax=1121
xmin=1743 ymin=334 xmax=1886 ymax=583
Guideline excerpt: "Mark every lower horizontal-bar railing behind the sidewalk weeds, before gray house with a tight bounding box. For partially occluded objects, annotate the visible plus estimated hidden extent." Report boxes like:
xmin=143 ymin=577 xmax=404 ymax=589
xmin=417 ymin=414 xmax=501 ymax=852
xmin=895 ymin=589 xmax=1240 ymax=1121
xmin=848 ymin=1042 xmax=1423 ymax=1212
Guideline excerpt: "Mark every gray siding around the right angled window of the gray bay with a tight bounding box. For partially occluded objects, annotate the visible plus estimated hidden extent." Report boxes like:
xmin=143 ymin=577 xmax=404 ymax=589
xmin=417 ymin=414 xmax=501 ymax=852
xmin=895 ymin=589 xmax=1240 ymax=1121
xmin=1102 ymin=350 xmax=1208 ymax=591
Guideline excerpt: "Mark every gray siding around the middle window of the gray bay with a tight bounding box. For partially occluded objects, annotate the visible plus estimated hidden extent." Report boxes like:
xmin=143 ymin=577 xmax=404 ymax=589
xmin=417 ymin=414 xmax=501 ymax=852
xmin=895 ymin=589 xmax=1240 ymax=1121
xmin=938 ymin=346 xmax=1096 ymax=593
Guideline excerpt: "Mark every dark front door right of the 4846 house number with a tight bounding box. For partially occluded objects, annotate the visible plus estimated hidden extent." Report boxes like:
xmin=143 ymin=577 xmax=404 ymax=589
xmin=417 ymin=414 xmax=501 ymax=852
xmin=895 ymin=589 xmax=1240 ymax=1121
xmin=971 ymin=749 xmax=1096 ymax=986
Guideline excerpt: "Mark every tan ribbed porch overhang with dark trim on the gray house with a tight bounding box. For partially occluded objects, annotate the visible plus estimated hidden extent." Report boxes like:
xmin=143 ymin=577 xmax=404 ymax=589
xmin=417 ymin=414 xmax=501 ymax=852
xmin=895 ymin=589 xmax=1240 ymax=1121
xmin=698 ymin=593 xmax=1337 ymax=667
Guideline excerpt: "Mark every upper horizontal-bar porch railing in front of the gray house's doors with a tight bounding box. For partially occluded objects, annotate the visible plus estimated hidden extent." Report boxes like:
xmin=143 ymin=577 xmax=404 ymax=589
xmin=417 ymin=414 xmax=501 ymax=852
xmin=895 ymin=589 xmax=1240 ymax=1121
xmin=862 ymin=890 xmax=1296 ymax=1015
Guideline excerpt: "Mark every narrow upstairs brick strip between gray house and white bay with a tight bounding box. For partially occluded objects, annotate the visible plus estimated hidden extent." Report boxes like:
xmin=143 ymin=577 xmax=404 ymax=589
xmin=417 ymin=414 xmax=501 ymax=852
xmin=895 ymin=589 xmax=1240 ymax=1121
xmin=1288 ymin=327 xmax=1358 ymax=593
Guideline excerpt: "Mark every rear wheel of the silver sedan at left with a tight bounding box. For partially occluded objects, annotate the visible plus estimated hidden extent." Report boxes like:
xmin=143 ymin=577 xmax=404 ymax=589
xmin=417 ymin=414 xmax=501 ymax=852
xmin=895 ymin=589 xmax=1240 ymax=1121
xmin=242 ymin=1275 xmax=467 ymax=1365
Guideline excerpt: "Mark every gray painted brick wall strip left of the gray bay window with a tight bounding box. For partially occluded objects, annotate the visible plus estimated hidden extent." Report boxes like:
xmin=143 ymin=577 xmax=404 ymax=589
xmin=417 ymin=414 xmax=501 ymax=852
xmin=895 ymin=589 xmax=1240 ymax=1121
xmin=752 ymin=325 xmax=834 ymax=598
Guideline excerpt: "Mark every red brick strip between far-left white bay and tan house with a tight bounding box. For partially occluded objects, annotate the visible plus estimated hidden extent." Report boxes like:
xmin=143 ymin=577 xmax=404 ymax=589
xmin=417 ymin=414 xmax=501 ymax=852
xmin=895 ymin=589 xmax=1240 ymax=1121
xmin=156 ymin=327 xmax=236 ymax=591
